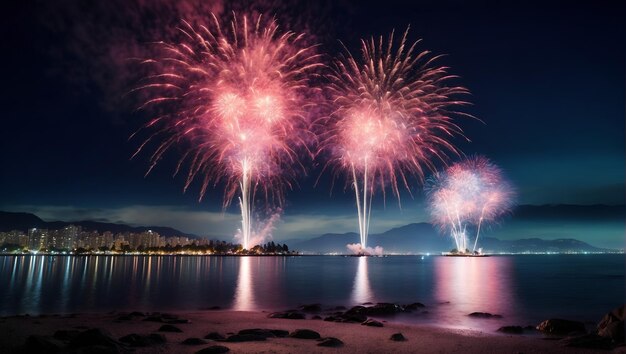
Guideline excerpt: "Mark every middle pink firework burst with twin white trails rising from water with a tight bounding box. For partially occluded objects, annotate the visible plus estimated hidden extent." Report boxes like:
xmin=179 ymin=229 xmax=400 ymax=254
xmin=321 ymin=29 xmax=468 ymax=249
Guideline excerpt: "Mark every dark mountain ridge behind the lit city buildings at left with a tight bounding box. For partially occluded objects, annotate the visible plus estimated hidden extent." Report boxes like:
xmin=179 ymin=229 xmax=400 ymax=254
xmin=0 ymin=211 xmax=198 ymax=238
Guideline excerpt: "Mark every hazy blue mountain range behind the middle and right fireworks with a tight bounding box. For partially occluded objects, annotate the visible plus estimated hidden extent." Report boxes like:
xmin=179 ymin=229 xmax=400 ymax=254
xmin=290 ymin=223 xmax=611 ymax=254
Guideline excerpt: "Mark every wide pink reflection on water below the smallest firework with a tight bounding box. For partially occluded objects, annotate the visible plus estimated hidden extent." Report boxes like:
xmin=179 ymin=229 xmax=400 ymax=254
xmin=434 ymin=257 xmax=515 ymax=327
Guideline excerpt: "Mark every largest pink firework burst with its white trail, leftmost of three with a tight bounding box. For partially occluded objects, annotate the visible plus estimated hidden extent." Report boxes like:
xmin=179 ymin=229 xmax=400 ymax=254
xmin=133 ymin=15 xmax=321 ymax=249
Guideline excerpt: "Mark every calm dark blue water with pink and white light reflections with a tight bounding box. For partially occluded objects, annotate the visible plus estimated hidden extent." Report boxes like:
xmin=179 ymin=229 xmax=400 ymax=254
xmin=0 ymin=255 xmax=626 ymax=330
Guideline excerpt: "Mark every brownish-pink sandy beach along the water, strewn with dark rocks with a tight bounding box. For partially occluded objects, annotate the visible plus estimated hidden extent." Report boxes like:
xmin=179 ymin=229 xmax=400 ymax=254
xmin=0 ymin=310 xmax=626 ymax=353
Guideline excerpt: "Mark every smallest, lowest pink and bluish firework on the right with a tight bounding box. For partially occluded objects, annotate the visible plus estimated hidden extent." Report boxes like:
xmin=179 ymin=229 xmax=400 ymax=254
xmin=427 ymin=156 xmax=515 ymax=253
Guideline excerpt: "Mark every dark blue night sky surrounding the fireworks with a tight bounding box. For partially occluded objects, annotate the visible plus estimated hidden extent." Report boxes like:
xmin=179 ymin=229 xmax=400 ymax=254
xmin=0 ymin=0 xmax=626 ymax=245
